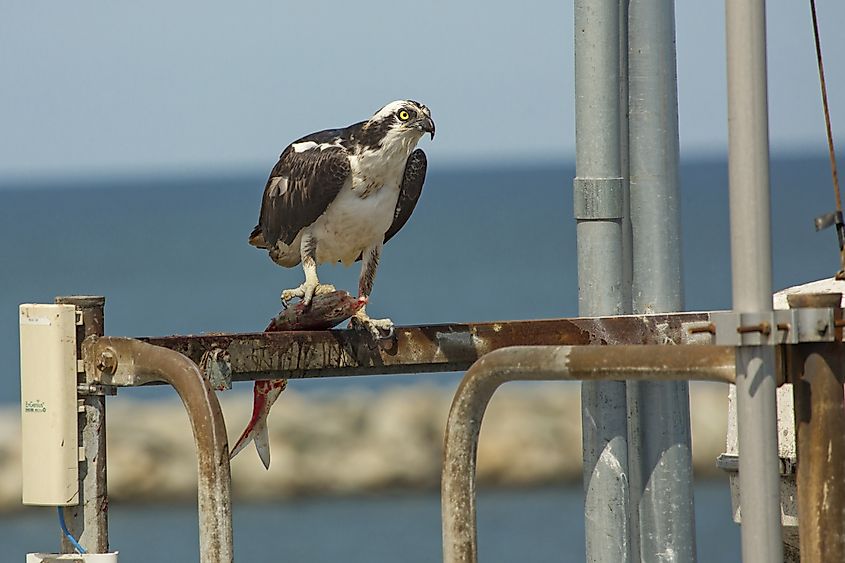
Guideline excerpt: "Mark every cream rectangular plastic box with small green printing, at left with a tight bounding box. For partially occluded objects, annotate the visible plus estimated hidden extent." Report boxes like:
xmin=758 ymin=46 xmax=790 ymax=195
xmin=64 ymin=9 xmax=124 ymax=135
xmin=20 ymin=304 xmax=79 ymax=506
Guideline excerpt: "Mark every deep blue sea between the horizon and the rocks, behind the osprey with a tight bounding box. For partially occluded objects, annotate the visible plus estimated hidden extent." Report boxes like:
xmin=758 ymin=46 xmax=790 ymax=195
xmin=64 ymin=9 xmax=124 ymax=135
xmin=0 ymin=155 xmax=838 ymax=404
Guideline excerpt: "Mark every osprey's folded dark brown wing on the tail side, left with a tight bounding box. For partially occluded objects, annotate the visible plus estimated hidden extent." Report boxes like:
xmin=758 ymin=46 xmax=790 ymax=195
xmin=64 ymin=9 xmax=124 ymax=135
xmin=250 ymin=143 xmax=350 ymax=248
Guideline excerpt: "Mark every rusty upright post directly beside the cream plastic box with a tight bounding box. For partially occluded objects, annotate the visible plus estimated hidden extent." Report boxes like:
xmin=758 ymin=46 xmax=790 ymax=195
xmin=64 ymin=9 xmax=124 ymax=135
xmin=56 ymin=296 xmax=109 ymax=553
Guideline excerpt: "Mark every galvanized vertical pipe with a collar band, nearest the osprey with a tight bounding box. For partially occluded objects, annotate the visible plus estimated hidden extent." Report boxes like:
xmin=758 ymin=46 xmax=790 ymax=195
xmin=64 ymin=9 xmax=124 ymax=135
xmin=574 ymin=0 xmax=630 ymax=563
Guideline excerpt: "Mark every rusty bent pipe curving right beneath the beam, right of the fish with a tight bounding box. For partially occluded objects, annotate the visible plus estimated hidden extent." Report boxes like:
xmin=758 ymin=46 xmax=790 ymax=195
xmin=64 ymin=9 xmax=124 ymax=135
xmin=441 ymin=345 xmax=736 ymax=563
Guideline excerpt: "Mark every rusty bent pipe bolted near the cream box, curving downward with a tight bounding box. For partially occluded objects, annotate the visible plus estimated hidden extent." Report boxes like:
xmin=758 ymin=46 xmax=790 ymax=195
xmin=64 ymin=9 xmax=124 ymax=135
xmin=82 ymin=337 xmax=233 ymax=563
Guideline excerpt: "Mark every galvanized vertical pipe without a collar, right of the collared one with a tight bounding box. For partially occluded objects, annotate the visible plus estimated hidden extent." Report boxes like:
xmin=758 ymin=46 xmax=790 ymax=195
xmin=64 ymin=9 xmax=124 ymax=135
xmin=628 ymin=0 xmax=695 ymax=561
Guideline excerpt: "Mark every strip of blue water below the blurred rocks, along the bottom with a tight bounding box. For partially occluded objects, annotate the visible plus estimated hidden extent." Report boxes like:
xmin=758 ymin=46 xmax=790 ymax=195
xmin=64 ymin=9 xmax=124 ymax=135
xmin=0 ymin=481 xmax=740 ymax=563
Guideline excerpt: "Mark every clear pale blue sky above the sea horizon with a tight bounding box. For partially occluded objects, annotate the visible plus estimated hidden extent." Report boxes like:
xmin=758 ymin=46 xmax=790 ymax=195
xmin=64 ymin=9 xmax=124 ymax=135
xmin=0 ymin=0 xmax=845 ymax=181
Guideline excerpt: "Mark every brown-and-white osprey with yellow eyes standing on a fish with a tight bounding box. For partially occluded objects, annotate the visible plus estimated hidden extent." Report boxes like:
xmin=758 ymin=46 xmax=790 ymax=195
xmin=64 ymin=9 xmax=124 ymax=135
xmin=249 ymin=100 xmax=434 ymax=337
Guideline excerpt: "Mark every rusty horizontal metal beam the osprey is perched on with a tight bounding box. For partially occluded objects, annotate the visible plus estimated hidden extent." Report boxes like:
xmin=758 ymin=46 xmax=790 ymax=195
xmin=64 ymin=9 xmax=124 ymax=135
xmin=130 ymin=313 xmax=709 ymax=388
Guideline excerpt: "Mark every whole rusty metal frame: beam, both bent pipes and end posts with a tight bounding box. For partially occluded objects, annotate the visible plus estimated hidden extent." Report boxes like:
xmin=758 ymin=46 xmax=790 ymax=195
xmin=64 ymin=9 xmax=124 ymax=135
xmin=44 ymin=300 xmax=845 ymax=563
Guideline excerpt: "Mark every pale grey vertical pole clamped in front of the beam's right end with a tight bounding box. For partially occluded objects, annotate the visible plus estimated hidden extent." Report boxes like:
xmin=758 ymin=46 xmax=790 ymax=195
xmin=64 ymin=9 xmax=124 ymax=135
xmin=725 ymin=0 xmax=783 ymax=563
